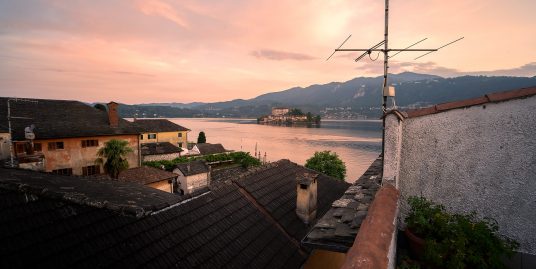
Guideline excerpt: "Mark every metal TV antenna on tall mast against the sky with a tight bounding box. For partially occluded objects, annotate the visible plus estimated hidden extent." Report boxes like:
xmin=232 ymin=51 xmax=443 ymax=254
xmin=326 ymin=0 xmax=463 ymax=113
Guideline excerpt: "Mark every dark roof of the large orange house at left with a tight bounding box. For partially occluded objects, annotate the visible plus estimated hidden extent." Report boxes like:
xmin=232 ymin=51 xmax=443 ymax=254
xmin=0 ymin=97 xmax=140 ymax=140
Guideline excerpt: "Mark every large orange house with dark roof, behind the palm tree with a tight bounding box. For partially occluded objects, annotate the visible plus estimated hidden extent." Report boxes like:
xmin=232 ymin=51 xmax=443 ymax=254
xmin=0 ymin=98 xmax=140 ymax=175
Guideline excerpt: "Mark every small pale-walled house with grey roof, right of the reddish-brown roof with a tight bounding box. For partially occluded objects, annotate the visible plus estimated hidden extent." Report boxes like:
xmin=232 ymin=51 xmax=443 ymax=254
xmin=173 ymin=160 xmax=211 ymax=194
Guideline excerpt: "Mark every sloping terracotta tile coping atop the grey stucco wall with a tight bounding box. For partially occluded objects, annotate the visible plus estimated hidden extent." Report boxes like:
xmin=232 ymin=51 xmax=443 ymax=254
xmin=401 ymin=86 xmax=536 ymax=118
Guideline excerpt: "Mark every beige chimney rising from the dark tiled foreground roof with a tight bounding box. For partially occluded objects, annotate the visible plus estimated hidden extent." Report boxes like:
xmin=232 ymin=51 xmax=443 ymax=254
xmin=296 ymin=172 xmax=318 ymax=224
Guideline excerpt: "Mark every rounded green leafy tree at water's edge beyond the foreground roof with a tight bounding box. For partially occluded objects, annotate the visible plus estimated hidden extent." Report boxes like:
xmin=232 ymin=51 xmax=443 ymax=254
xmin=305 ymin=150 xmax=346 ymax=180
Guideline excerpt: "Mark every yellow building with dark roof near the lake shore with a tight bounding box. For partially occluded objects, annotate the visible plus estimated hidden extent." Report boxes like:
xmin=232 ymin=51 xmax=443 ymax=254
xmin=134 ymin=119 xmax=190 ymax=148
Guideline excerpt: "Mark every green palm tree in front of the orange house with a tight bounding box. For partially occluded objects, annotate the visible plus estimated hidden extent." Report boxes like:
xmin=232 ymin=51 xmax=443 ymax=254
xmin=97 ymin=139 xmax=132 ymax=178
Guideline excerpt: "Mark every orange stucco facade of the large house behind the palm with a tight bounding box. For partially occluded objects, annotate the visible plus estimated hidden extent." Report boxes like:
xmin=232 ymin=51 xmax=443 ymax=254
xmin=34 ymin=135 xmax=139 ymax=175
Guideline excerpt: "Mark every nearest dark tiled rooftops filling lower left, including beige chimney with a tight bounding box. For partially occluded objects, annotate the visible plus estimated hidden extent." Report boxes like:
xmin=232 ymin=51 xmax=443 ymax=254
xmin=0 ymin=160 xmax=349 ymax=268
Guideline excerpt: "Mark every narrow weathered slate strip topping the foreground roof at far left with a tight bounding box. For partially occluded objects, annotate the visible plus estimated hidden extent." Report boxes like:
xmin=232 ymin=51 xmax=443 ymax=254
xmin=0 ymin=168 xmax=180 ymax=217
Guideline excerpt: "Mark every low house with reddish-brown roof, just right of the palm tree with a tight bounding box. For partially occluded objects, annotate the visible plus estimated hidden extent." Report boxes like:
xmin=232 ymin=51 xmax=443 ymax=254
xmin=118 ymin=166 xmax=177 ymax=193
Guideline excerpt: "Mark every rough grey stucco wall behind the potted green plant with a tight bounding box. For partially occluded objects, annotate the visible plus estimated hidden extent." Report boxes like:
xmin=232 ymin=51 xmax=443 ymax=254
xmin=391 ymin=96 xmax=536 ymax=254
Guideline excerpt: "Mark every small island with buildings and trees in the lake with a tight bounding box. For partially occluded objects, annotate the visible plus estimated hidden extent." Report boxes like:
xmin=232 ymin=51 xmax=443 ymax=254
xmin=257 ymin=107 xmax=320 ymax=126
